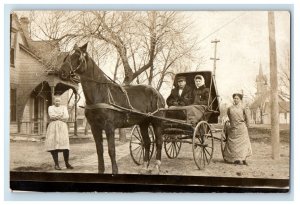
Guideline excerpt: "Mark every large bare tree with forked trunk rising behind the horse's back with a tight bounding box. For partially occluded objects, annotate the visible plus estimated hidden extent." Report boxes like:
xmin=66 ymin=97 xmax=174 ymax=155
xmin=73 ymin=11 xmax=204 ymax=85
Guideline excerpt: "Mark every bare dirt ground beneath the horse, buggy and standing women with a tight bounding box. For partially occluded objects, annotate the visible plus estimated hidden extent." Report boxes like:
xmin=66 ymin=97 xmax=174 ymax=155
xmin=10 ymin=129 xmax=290 ymax=179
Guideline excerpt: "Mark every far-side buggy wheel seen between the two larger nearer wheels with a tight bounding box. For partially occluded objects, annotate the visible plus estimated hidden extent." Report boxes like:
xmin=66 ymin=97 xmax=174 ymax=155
xmin=164 ymin=135 xmax=182 ymax=159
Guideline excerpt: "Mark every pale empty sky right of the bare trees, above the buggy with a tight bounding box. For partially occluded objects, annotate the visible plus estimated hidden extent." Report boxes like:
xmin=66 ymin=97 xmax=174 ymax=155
xmin=188 ymin=11 xmax=290 ymax=104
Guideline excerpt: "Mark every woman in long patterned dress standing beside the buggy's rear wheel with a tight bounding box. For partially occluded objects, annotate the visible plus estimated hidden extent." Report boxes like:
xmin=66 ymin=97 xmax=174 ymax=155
xmin=224 ymin=93 xmax=252 ymax=165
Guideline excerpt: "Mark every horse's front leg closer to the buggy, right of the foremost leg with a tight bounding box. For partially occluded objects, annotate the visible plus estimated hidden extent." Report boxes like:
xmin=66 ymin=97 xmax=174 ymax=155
xmin=105 ymin=126 xmax=118 ymax=174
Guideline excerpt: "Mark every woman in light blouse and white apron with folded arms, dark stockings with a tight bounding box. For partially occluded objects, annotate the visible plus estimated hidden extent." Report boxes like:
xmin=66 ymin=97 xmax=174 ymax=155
xmin=45 ymin=97 xmax=73 ymax=170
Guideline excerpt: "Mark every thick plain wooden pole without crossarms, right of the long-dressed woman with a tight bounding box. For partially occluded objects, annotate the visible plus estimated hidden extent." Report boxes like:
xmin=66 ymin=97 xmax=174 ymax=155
xmin=268 ymin=11 xmax=280 ymax=160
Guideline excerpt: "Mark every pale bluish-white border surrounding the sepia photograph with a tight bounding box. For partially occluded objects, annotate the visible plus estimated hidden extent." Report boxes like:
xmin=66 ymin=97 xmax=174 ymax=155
xmin=0 ymin=0 xmax=300 ymax=204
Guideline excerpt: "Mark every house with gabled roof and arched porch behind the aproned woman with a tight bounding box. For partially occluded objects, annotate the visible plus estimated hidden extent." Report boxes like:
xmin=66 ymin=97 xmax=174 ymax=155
xmin=10 ymin=13 xmax=78 ymax=135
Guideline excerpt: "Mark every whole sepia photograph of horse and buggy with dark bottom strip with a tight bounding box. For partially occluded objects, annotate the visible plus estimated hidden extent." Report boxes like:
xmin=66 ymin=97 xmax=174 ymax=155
xmin=8 ymin=10 xmax=292 ymax=193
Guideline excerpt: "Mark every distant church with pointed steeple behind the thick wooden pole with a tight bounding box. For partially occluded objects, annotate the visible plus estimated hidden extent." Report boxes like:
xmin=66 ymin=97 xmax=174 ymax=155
xmin=250 ymin=64 xmax=290 ymax=124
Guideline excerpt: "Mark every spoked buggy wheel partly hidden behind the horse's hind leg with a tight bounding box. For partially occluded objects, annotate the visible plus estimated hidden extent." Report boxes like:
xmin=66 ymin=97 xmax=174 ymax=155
xmin=129 ymin=125 xmax=155 ymax=165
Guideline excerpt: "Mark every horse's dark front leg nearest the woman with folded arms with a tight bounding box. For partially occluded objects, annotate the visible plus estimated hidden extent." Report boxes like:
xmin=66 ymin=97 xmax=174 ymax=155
xmin=91 ymin=124 xmax=105 ymax=174
